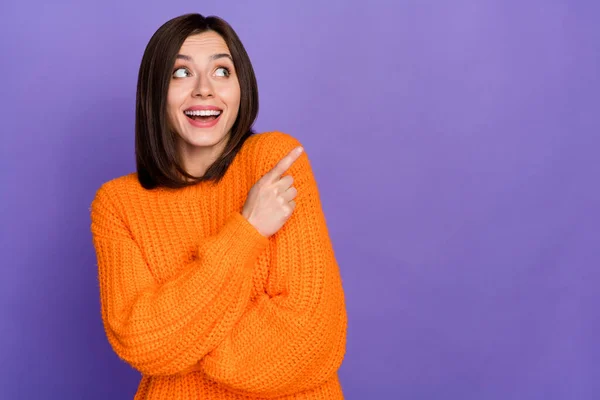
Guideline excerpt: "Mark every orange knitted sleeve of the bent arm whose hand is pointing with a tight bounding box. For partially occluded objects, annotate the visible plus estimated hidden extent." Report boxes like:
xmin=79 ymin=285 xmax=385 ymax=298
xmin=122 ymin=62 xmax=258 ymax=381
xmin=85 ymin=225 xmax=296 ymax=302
xmin=91 ymin=185 xmax=268 ymax=375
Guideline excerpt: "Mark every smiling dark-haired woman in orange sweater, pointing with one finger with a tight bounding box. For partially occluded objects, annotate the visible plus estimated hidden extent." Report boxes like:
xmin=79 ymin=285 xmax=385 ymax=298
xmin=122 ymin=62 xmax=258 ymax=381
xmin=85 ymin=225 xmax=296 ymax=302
xmin=91 ymin=14 xmax=347 ymax=399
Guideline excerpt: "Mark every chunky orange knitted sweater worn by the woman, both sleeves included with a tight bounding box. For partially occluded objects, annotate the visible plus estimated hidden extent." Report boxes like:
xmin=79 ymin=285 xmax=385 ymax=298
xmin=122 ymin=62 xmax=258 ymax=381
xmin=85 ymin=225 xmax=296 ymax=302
xmin=91 ymin=132 xmax=347 ymax=400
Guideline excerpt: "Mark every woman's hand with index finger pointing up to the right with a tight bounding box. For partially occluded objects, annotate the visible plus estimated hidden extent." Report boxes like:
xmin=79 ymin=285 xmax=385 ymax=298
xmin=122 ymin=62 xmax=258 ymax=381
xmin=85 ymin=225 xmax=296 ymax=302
xmin=242 ymin=147 xmax=303 ymax=237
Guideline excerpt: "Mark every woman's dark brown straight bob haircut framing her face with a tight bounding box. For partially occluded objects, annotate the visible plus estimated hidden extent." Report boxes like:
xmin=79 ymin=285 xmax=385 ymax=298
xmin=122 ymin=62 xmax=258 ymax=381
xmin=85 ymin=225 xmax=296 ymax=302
xmin=135 ymin=14 xmax=258 ymax=189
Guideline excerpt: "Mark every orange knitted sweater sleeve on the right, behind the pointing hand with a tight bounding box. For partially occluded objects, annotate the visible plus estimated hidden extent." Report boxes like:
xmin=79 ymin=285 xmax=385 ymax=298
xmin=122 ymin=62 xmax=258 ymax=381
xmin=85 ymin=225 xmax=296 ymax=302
xmin=197 ymin=136 xmax=347 ymax=398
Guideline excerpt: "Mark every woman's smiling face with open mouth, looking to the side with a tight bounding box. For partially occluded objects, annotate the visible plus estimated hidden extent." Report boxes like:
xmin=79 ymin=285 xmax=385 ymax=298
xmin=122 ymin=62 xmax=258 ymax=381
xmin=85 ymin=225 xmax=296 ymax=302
xmin=167 ymin=31 xmax=240 ymax=172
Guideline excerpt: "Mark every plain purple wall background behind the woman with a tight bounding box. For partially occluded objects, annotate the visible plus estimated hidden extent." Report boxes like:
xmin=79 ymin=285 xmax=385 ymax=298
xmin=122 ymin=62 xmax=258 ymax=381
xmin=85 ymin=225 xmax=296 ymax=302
xmin=0 ymin=0 xmax=600 ymax=400
